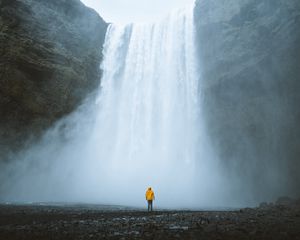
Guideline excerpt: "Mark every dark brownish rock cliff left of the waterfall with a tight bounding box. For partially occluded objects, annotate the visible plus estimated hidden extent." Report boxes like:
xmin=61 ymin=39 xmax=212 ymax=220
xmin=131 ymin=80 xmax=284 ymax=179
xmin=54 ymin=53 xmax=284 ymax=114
xmin=0 ymin=0 xmax=107 ymax=156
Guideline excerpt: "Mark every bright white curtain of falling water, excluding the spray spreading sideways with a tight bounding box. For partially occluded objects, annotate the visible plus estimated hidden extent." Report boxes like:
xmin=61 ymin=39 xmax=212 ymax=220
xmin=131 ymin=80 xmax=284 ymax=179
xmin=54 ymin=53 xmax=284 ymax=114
xmin=86 ymin=4 xmax=200 ymax=203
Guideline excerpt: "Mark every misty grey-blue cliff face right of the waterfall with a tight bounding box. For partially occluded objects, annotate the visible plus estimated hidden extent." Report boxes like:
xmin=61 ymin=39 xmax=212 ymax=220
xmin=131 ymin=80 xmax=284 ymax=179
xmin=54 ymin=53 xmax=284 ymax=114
xmin=195 ymin=0 xmax=300 ymax=198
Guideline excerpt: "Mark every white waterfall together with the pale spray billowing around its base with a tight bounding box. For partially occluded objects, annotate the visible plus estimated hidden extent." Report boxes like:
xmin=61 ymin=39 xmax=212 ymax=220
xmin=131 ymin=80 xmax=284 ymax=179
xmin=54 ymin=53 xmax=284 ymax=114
xmin=0 ymin=3 xmax=230 ymax=207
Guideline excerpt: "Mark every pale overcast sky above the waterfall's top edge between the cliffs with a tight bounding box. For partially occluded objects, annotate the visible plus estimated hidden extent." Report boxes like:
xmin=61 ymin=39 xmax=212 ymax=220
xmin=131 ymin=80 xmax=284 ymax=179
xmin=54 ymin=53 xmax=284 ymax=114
xmin=81 ymin=0 xmax=194 ymax=23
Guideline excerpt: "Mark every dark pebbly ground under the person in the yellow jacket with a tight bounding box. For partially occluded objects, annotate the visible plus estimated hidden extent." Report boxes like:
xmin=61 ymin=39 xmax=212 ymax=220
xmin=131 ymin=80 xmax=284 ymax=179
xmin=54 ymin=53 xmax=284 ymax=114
xmin=0 ymin=198 xmax=300 ymax=240
